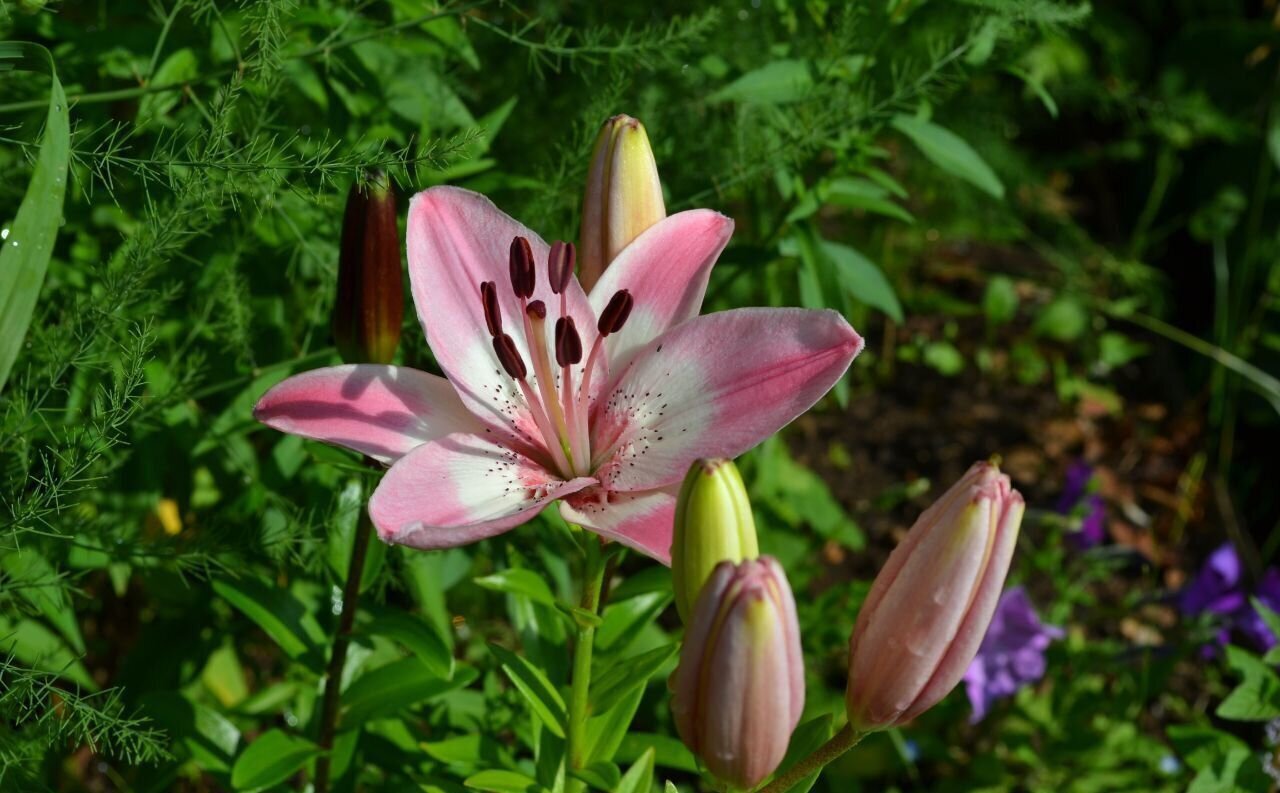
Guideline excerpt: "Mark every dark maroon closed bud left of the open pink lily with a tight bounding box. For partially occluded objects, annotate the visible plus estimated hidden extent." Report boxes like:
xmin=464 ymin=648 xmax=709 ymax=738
xmin=333 ymin=171 xmax=404 ymax=363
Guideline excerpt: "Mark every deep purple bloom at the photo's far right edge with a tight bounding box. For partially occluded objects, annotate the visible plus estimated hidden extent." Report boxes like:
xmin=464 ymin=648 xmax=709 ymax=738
xmin=1178 ymin=542 xmax=1280 ymax=650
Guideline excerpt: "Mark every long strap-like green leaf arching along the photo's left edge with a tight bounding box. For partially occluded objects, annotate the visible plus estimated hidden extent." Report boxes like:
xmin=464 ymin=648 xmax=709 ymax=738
xmin=0 ymin=41 xmax=70 ymax=391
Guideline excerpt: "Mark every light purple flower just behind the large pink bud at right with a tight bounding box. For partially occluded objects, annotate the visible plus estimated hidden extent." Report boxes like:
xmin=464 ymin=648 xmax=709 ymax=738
xmin=964 ymin=587 xmax=1062 ymax=723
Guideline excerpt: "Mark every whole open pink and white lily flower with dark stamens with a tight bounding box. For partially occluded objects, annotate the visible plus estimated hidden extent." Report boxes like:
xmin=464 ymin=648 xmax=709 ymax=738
xmin=253 ymin=187 xmax=863 ymax=564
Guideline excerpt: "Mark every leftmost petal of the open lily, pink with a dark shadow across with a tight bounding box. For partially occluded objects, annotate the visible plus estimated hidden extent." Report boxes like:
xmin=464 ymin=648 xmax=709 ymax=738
xmin=253 ymin=363 xmax=481 ymax=463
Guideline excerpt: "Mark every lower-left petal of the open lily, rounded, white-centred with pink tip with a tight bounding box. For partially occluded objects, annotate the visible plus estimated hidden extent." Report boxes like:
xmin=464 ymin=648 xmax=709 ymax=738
xmin=369 ymin=432 xmax=595 ymax=549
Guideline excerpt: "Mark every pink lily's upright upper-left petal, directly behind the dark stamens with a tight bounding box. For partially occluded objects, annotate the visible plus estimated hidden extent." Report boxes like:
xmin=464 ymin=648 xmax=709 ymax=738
xmin=407 ymin=187 xmax=596 ymax=443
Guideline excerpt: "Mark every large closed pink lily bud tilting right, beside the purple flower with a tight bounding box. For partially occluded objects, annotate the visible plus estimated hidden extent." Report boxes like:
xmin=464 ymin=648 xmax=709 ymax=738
xmin=845 ymin=463 xmax=1024 ymax=730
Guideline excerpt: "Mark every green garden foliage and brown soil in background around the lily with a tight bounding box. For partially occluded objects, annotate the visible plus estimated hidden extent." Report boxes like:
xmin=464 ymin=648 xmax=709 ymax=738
xmin=0 ymin=0 xmax=1280 ymax=792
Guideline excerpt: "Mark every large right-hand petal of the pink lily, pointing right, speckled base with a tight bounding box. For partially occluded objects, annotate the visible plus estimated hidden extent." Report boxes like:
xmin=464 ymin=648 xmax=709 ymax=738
xmin=591 ymin=308 xmax=863 ymax=491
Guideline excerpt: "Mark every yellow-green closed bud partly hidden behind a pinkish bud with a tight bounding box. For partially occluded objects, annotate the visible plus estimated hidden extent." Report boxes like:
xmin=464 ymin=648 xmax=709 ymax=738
xmin=671 ymin=459 xmax=760 ymax=623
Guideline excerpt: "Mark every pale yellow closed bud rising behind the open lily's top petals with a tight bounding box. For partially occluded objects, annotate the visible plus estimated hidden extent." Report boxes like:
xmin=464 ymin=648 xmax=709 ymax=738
xmin=579 ymin=115 xmax=667 ymax=292
